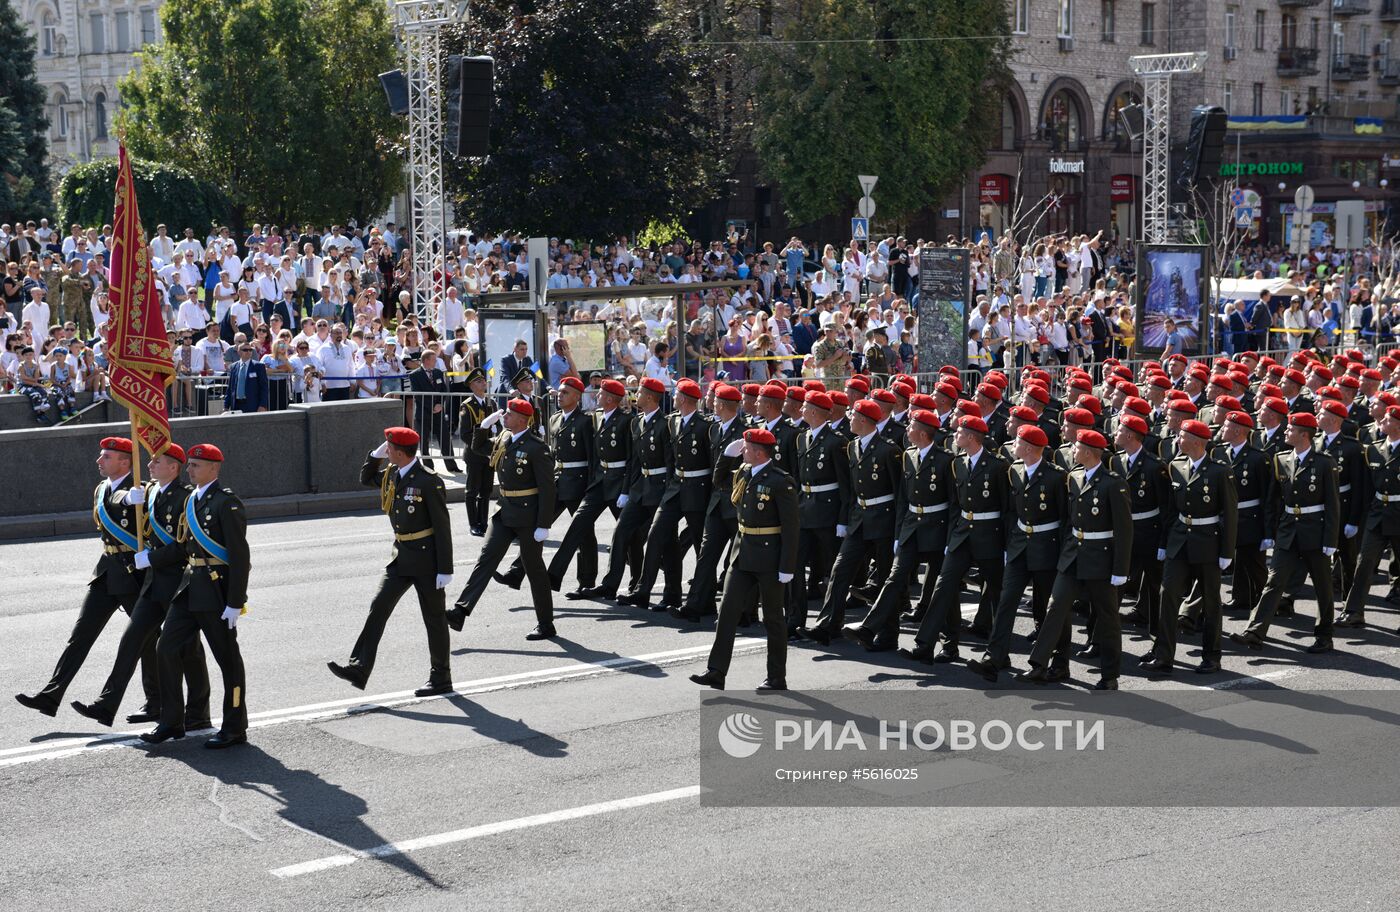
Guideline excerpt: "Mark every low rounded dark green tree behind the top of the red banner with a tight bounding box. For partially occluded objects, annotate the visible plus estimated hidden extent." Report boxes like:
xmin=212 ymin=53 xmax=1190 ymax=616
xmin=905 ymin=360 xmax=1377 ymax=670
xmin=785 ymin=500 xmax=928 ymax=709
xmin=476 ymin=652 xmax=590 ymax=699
xmin=59 ymin=158 xmax=228 ymax=237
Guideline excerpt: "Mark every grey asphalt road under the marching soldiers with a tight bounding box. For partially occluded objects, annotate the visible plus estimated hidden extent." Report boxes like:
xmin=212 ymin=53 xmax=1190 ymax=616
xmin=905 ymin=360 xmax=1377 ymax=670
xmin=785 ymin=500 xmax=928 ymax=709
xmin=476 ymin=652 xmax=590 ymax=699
xmin=0 ymin=507 xmax=1400 ymax=912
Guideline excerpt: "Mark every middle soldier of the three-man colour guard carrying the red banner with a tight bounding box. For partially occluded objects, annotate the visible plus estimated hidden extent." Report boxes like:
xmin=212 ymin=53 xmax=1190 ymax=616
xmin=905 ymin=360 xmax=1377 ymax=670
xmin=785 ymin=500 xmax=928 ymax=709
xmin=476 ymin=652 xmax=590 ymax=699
xmin=71 ymin=443 xmax=210 ymax=731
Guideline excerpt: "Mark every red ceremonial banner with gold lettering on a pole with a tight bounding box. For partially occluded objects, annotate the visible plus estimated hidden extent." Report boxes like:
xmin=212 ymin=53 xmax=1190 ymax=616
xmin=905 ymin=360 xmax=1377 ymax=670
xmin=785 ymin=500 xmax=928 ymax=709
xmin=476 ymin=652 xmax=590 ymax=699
xmin=106 ymin=144 xmax=175 ymax=455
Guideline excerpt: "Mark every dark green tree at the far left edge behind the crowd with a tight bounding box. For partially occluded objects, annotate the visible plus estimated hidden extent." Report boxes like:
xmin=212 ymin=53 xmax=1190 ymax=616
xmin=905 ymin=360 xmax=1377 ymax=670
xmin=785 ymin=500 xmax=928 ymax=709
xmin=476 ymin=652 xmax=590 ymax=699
xmin=0 ymin=3 xmax=53 ymax=221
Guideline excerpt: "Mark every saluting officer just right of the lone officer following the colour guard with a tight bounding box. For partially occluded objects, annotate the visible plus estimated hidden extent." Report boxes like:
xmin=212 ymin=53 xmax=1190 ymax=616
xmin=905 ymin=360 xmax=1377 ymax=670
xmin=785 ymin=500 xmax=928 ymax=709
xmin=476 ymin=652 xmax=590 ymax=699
xmin=447 ymin=399 xmax=556 ymax=640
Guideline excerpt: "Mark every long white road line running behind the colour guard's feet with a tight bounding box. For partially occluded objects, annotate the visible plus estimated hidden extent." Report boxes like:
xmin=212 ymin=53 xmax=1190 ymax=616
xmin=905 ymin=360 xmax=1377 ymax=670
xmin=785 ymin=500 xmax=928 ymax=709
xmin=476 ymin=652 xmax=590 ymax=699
xmin=0 ymin=637 xmax=767 ymax=768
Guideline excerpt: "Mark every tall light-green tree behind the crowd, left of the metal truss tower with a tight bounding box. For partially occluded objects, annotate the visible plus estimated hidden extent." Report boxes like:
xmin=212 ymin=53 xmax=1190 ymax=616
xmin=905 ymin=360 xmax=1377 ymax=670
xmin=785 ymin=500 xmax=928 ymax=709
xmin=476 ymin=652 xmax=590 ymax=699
xmin=119 ymin=0 xmax=402 ymax=227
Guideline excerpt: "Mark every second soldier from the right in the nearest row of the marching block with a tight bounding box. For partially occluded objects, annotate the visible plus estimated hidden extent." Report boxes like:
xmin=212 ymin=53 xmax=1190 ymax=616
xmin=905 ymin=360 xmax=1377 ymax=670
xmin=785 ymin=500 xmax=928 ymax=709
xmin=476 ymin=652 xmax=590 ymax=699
xmin=1229 ymin=412 xmax=1340 ymax=653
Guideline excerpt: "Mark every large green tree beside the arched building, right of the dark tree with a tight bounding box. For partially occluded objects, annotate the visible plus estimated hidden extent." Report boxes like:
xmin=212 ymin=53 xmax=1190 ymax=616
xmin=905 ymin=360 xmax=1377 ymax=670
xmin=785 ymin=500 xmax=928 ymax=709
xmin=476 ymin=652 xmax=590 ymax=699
xmin=753 ymin=0 xmax=1009 ymax=223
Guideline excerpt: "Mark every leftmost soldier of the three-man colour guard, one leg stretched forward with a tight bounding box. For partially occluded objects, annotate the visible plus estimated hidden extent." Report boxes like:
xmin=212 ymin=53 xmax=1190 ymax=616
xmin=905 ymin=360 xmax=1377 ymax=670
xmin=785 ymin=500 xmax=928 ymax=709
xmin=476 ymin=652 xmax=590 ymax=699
xmin=14 ymin=437 xmax=161 ymax=716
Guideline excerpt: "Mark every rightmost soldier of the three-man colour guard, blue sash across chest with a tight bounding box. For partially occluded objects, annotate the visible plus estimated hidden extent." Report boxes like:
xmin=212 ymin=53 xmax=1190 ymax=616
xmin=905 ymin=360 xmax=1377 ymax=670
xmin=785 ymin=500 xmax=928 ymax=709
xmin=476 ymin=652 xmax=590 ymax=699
xmin=141 ymin=443 xmax=252 ymax=749
